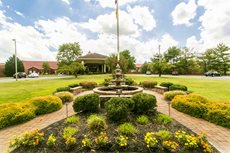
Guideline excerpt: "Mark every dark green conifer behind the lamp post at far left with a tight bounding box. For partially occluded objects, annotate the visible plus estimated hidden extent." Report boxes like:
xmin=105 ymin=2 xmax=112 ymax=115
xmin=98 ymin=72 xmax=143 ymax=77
xmin=4 ymin=55 xmax=24 ymax=77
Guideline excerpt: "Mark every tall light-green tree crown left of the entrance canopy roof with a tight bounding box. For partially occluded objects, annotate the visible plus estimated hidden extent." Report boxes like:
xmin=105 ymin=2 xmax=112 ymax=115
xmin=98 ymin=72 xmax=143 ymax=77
xmin=57 ymin=43 xmax=81 ymax=65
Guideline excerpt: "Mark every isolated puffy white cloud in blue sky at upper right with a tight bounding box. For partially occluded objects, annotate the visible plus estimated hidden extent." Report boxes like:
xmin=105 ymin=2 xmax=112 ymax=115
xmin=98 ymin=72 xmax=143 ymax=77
xmin=171 ymin=0 xmax=197 ymax=26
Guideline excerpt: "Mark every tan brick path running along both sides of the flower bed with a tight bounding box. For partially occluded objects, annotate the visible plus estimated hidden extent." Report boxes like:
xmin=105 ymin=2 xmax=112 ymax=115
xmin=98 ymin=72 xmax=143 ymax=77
xmin=0 ymin=90 xmax=230 ymax=153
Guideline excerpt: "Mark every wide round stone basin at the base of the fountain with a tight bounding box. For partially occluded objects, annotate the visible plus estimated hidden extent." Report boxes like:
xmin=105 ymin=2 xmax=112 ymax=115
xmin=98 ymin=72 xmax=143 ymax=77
xmin=93 ymin=85 xmax=143 ymax=95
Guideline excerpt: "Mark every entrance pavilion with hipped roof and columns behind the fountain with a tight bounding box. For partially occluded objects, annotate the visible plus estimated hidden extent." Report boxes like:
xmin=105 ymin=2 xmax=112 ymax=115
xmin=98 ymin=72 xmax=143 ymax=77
xmin=77 ymin=52 xmax=109 ymax=73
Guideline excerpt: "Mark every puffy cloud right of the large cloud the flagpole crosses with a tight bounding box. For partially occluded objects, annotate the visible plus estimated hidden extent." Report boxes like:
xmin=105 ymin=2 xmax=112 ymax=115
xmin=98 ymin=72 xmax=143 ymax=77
xmin=127 ymin=6 xmax=156 ymax=31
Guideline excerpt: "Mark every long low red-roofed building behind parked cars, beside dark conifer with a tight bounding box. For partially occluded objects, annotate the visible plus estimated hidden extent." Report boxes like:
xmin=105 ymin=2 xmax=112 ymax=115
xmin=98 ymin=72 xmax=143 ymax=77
xmin=22 ymin=61 xmax=58 ymax=74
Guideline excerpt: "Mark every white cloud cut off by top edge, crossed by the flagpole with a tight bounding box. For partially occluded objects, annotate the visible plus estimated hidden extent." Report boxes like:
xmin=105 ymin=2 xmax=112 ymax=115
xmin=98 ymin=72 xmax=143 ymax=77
xmin=95 ymin=0 xmax=137 ymax=8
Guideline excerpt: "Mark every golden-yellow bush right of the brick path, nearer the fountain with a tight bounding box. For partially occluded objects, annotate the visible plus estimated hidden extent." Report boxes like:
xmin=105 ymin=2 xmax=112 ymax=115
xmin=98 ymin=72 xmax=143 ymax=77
xmin=172 ymin=94 xmax=208 ymax=118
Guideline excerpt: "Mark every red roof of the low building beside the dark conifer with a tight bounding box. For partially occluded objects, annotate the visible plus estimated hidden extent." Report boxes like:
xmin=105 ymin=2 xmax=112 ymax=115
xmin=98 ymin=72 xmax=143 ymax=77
xmin=22 ymin=61 xmax=57 ymax=70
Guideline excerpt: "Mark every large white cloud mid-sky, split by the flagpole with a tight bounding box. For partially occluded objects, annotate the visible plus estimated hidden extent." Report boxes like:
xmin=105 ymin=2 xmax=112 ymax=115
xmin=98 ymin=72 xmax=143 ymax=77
xmin=80 ymin=10 xmax=139 ymax=37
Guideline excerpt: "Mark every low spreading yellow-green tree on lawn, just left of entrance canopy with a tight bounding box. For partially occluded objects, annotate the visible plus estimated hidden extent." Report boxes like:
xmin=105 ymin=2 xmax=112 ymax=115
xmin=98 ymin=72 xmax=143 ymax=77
xmin=57 ymin=62 xmax=85 ymax=77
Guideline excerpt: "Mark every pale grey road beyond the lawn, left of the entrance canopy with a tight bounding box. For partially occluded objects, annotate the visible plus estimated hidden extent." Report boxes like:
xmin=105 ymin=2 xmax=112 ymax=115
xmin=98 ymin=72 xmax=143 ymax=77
xmin=0 ymin=76 xmax=73 ymax=83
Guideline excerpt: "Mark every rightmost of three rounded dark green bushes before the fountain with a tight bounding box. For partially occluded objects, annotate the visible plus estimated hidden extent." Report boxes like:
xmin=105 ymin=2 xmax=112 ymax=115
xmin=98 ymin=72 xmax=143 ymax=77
xmin=132 ymin=93 xmax=157 ymax=114
